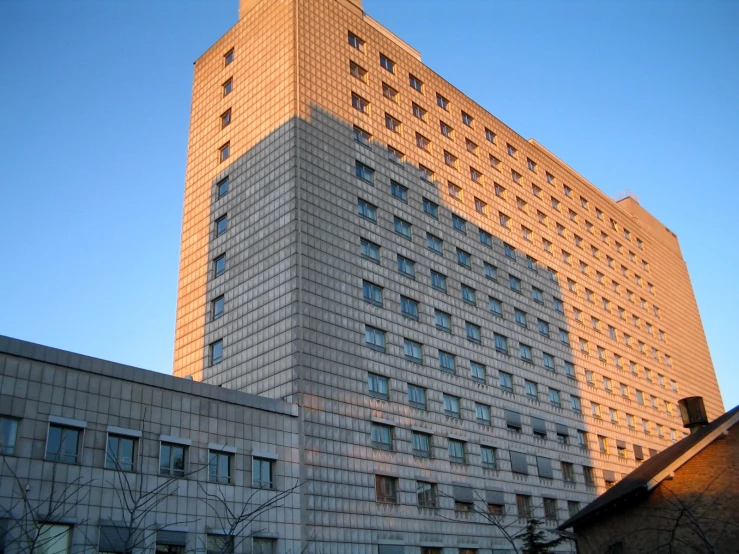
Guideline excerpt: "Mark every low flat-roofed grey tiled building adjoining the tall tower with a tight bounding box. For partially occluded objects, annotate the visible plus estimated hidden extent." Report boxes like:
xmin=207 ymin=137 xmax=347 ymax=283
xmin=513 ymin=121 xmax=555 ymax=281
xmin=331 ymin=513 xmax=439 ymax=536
xmin=0 ymin=337 xmax=301 ymax=554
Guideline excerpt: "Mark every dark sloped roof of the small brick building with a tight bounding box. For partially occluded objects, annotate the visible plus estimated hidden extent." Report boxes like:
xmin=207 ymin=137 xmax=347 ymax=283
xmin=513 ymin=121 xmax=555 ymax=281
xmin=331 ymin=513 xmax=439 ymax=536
xmin=557 ymin=406 xmax=739 ymax=530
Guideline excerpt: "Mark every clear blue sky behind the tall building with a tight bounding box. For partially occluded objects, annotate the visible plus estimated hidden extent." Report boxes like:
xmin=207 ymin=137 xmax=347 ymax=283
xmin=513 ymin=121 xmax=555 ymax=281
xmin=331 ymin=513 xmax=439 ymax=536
xmin=0 ymin=0 xmax=739 ymax=408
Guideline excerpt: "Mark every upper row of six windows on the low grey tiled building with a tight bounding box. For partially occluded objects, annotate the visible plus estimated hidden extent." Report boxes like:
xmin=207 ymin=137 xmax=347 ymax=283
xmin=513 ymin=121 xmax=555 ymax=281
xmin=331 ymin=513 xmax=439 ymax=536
xmin=0 ymin=416 xmax=275 ymax=489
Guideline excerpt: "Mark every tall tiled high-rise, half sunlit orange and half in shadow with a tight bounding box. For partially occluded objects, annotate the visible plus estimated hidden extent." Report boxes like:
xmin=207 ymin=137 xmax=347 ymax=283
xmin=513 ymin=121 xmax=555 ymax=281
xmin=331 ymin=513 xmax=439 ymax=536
xmin=174 ymin=0 xmax=724 ymax=554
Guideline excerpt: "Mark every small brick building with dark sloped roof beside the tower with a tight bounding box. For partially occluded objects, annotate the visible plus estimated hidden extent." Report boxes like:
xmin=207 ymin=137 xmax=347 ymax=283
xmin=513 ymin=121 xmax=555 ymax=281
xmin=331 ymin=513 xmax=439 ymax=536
xmin=559 ymin=406 xmax=739 ymax=554
